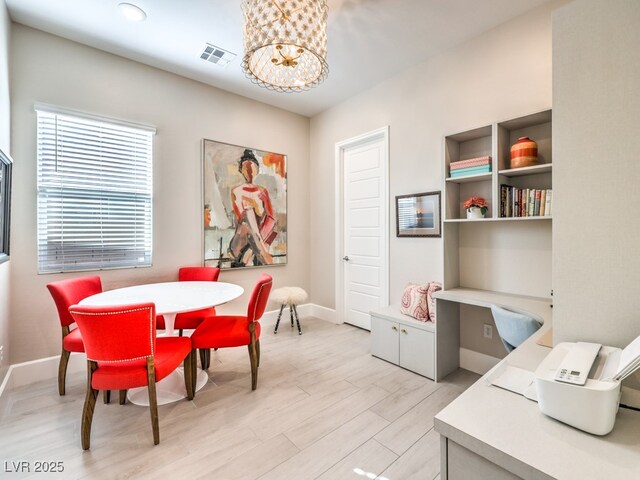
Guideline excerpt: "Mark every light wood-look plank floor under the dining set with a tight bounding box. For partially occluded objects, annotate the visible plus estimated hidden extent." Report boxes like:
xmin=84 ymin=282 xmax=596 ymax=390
xmin=0 ymin=318 xmax=478 ymax=480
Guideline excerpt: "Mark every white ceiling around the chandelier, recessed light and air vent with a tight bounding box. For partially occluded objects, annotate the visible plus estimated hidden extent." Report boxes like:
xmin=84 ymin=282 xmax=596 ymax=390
xmin=5 ymin=0 xmax=549 ymax=116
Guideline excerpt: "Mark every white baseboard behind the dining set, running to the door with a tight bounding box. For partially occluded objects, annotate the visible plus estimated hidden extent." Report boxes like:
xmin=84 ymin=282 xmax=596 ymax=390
xmin=0 ymin=303 xmax=338 ymax=396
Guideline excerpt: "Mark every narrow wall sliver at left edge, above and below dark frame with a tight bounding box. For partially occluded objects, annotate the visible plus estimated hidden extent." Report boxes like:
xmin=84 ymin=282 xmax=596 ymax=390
xmin=0 ymin=2 xmax=11 ymax=383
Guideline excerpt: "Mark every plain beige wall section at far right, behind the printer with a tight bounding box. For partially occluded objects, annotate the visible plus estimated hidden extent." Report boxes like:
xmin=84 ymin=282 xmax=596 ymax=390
xmin=553 ymin=0 xmax=640 ymax=346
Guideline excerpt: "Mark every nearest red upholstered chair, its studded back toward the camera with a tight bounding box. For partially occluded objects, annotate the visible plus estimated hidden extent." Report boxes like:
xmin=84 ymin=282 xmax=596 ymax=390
xmin=69 ymin=303 xmax=196 ymax=450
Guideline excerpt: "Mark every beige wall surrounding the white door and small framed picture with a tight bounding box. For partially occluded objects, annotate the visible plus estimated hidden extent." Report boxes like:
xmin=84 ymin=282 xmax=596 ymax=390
xmin=310 ymin=1 xmax=563 ymax=308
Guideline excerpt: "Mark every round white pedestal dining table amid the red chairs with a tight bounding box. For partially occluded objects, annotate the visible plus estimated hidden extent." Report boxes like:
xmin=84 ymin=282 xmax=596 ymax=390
xmin=79 ymin=282 xmax=244 ymax=405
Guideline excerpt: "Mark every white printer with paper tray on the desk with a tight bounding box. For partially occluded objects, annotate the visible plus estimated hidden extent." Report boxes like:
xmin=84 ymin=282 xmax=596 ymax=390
xmin=535 ymin=337 xmax=640 ymax=435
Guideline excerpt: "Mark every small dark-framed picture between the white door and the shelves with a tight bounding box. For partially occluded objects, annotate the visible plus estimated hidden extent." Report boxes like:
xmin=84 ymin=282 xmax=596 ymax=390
xmin=396 ymin=192 xmax=442 ymax=237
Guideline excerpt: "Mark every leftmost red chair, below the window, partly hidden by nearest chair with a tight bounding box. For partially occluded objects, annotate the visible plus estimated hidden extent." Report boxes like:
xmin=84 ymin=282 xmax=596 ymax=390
xmin=47 ymin=277 xmax=102 ymax=395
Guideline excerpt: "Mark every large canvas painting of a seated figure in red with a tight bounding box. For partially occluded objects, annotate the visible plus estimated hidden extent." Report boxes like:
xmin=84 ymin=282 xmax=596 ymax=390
xmin=202 ymin=140 xmax=287 ymax=268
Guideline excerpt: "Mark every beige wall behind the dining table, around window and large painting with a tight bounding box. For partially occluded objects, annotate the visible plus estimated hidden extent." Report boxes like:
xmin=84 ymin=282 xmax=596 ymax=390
xmin=9 ymin=24 xmax=309 ymax=363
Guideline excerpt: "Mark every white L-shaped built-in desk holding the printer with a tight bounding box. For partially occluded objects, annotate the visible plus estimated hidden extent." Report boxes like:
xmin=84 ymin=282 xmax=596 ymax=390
xmin=434 ymin=289 xmax=640 ymax=480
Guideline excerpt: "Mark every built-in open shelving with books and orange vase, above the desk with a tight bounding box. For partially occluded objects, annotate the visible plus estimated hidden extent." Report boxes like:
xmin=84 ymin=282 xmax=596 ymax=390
xmin=443 ymin=110 xmax=553 ymax=294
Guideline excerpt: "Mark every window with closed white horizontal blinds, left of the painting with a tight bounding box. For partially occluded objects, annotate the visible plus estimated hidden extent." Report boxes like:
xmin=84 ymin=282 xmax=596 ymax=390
xmin=36 ymin=105 xmax=155 ymax=273
